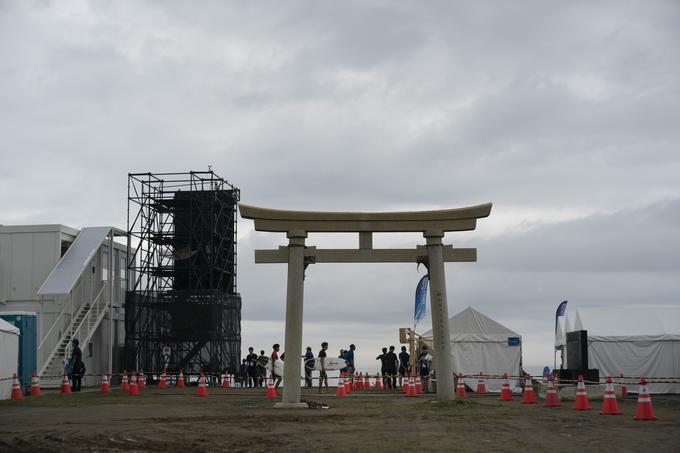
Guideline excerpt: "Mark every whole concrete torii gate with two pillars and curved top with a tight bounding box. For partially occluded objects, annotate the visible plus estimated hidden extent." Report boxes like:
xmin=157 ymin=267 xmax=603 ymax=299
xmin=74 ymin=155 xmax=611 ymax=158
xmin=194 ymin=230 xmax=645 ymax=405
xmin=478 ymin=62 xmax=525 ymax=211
xmin=239 ymin=203 xmax=491 ymax=407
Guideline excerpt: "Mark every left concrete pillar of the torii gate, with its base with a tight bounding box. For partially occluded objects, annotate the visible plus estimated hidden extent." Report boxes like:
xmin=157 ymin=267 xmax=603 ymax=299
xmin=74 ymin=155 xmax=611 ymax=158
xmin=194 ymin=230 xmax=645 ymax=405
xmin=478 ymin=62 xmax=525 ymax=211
xmin=274 ymin=231 xmax=307 ymax=408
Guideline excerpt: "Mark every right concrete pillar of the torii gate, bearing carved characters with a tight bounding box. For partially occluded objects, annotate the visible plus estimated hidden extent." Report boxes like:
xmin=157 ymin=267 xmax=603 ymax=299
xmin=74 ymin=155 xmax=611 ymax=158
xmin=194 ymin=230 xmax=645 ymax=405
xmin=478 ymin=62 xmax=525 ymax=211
xmin=423 ymin=231 xmax=456 ymax=401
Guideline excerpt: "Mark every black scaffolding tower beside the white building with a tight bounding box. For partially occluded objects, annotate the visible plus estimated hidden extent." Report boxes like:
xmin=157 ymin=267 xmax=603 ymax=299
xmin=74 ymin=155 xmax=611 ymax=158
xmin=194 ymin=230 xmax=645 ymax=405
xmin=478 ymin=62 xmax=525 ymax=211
xmin=125 ymin=171 xmax=241 ymax=373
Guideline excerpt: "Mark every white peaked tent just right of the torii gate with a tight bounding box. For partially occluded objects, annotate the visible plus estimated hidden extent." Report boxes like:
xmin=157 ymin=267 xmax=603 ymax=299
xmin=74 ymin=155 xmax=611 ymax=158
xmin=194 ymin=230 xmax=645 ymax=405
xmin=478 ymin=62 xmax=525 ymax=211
xmin=424 ymin=307 xmax=522 ymax=391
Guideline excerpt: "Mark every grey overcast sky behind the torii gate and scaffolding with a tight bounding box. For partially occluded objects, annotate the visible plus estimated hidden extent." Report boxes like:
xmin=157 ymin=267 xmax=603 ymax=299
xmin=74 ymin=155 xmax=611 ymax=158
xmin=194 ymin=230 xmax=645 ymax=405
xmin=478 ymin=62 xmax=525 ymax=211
xmin=0 ymin=0 xmax=680 ymax=370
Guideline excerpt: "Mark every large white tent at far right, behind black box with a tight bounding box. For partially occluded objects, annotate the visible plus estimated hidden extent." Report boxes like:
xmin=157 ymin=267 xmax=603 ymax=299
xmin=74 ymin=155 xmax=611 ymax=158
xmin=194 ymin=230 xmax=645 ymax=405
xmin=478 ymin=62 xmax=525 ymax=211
xmin=567 ymin=305 xmax=680 ymax=393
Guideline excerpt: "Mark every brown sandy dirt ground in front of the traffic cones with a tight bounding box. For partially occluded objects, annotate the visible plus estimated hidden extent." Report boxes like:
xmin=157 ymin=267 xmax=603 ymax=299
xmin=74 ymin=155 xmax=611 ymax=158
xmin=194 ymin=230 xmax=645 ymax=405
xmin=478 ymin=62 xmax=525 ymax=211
xmin=0 ymin=387 xmax=680 ymax=452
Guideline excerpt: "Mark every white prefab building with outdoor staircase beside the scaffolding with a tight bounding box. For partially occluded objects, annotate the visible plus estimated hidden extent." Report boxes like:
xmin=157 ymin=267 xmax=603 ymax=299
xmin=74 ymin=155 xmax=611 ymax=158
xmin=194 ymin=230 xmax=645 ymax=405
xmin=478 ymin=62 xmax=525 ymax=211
xmin=0 ymin=225 xmax=128 ymax=386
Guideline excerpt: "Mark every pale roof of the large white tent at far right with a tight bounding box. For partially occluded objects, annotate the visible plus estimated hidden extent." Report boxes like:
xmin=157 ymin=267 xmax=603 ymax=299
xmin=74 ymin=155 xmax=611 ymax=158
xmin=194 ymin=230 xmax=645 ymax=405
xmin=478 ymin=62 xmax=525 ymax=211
xmin=570 ymin=305 xmax=680 ymax=336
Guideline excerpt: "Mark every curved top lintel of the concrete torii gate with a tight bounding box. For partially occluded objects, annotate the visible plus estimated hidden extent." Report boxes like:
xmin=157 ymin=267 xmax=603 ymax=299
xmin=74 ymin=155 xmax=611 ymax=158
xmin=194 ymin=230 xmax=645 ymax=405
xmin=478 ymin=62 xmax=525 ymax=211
xmin=239 ymin=203 xmax=492 ymax=233
